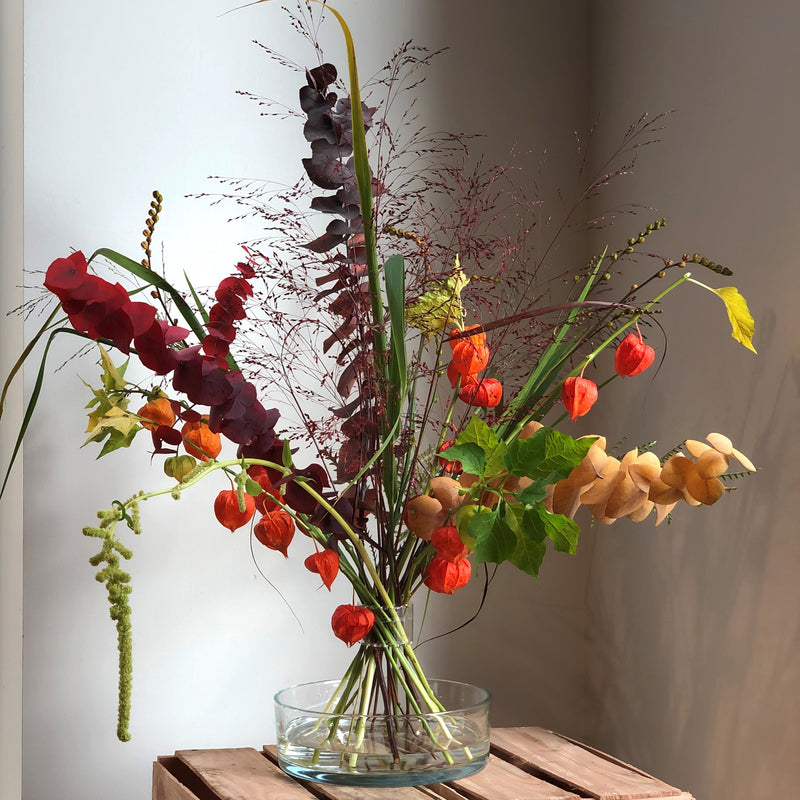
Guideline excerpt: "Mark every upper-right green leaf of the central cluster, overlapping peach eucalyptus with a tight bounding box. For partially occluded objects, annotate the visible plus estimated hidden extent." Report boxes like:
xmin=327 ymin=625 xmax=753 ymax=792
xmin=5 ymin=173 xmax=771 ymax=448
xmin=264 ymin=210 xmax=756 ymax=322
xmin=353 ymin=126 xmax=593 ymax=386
xmin=503 ymin=428 xmax=596 ymax=483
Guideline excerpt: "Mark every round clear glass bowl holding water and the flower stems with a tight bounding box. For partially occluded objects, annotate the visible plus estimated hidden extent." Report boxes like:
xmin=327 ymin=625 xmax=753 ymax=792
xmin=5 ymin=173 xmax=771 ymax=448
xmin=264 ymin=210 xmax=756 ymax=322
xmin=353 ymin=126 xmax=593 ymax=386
xmin=275 ymin=680 xmax=490 ymax=786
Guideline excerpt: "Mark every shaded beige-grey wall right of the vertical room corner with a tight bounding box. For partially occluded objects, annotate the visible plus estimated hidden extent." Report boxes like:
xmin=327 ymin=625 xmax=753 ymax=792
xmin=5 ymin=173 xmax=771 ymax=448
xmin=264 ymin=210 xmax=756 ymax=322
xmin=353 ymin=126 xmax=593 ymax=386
xmin=588 ymin=2 xmax=800 ymax=800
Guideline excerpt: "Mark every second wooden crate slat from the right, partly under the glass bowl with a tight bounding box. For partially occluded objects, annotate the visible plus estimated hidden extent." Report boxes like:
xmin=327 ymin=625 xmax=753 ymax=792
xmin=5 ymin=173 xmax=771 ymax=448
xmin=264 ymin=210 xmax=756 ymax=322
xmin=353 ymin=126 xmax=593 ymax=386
xmin=435 ymin=755 xmax=580 ymax=800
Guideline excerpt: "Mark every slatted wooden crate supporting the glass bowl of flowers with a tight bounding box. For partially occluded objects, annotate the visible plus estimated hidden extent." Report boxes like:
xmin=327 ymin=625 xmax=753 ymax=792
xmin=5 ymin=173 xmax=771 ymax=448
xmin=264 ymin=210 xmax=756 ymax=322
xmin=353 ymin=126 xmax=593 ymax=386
xmin=153 ymin=728 xmax=693 ymax=800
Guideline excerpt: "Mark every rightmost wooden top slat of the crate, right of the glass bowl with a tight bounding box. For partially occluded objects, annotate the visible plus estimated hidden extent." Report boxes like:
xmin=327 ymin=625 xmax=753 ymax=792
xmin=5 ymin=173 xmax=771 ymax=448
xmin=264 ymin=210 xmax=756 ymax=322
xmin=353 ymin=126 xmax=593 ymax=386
xmin=492 ymin=728 xmax=685 ymax=800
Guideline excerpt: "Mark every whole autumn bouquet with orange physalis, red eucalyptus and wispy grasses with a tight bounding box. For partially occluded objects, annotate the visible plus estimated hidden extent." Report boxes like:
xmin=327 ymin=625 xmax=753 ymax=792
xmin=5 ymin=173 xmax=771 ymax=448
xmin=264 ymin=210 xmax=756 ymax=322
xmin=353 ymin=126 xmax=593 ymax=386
xmin=3 ymin=0 xmax=755 ymax=768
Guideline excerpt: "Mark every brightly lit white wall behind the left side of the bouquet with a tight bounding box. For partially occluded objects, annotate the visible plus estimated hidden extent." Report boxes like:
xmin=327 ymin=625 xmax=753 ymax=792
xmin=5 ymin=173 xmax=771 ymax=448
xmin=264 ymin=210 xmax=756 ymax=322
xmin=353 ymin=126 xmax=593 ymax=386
xmin=18 ymin=0 xmax=568 ymax=800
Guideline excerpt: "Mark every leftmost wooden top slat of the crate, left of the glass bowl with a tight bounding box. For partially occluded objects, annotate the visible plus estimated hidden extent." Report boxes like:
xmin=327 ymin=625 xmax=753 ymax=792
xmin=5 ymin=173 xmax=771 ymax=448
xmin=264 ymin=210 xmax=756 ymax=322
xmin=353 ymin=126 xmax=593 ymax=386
xmin=175 ymin=747 xmax=310 ymax=800
